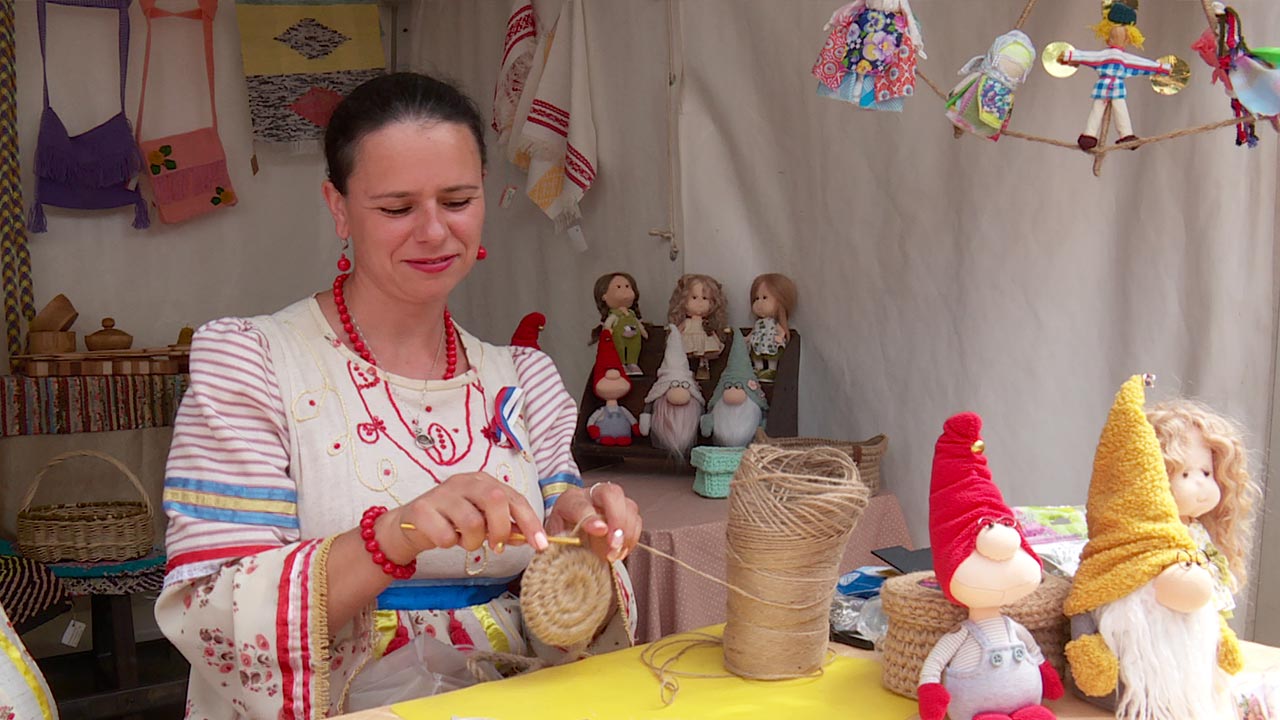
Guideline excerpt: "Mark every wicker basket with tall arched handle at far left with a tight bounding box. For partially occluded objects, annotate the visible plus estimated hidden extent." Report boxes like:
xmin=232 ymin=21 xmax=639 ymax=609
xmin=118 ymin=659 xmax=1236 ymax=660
xmin=18 ymin=450 xmax=152 ymax=562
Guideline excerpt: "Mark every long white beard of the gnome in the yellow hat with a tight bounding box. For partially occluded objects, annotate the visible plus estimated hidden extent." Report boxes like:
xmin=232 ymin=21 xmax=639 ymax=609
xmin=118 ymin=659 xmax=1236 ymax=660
xmin=1094 ymin=582 xmax=1222 ymax=720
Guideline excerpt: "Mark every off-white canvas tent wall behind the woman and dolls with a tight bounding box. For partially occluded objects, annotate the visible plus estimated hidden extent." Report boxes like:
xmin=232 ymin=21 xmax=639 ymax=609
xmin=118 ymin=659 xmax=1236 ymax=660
xmin=0 ymin=0 xmax=1280 ymax=643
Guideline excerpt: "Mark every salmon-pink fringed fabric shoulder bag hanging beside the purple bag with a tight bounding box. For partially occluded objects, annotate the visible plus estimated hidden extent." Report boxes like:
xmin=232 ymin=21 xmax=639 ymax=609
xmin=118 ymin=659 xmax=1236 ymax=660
xmin=137 ymin=0 xmax=237 ymax=224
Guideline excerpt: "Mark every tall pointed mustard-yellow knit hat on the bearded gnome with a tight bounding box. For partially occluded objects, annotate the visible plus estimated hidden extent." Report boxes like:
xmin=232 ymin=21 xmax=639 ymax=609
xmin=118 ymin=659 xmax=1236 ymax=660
xmin=1064 ymin=375 xmax=1196 ymax=615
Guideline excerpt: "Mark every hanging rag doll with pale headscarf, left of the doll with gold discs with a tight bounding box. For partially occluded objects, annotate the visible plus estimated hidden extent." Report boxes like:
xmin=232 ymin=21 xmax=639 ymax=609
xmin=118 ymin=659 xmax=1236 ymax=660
xmin=947 ymin=29 xmax=1036 ymax=141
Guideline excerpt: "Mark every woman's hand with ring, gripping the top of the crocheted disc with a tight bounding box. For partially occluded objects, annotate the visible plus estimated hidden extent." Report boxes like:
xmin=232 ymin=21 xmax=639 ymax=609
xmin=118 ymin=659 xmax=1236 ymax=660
xmin=545 ymin=483 xmax=643 ymax=562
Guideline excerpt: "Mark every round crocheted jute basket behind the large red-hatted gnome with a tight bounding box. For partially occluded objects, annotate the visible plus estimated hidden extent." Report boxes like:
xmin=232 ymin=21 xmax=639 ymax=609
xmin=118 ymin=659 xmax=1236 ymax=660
xmin=877 ymin=571 xmax=1071 ymax=698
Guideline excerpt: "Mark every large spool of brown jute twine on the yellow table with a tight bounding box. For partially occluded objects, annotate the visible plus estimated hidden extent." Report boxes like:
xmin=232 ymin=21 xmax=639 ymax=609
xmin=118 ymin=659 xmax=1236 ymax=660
xmin=724 ymin=445 xmax=868 ymax=680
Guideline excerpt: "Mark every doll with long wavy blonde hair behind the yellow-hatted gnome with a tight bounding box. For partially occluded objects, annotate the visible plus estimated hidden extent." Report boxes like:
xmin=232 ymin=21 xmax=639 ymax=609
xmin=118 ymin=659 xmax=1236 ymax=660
xmin=1147 ymin=397 xmax=1260 ymax=618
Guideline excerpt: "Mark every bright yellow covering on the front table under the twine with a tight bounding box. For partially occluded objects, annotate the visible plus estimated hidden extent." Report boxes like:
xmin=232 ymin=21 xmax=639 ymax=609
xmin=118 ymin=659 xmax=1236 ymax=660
xmin=392 ymin=626 xmax=916 ymax=720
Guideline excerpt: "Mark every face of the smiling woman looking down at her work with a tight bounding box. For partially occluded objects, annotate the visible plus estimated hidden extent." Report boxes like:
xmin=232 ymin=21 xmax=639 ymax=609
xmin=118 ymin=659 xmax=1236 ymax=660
xmin=324 ymin=120 xmax=484 ymax=302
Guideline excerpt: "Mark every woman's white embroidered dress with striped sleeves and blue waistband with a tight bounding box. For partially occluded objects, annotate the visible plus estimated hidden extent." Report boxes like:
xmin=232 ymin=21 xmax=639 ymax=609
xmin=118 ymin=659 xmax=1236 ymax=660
xmin=156 ymin=299 xmax=635 ymax=720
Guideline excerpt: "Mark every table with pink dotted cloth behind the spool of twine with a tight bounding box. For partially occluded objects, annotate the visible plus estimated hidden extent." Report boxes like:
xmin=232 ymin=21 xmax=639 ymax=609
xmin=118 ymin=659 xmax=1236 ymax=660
xmin=582 ymin=461 xmax=911 ymax=643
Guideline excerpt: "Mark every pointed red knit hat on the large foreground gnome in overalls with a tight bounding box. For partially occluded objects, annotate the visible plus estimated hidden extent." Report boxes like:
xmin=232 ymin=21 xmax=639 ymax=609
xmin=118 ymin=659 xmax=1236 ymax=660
xmin=929 ymin=413 xmax=1043 ymax=605
